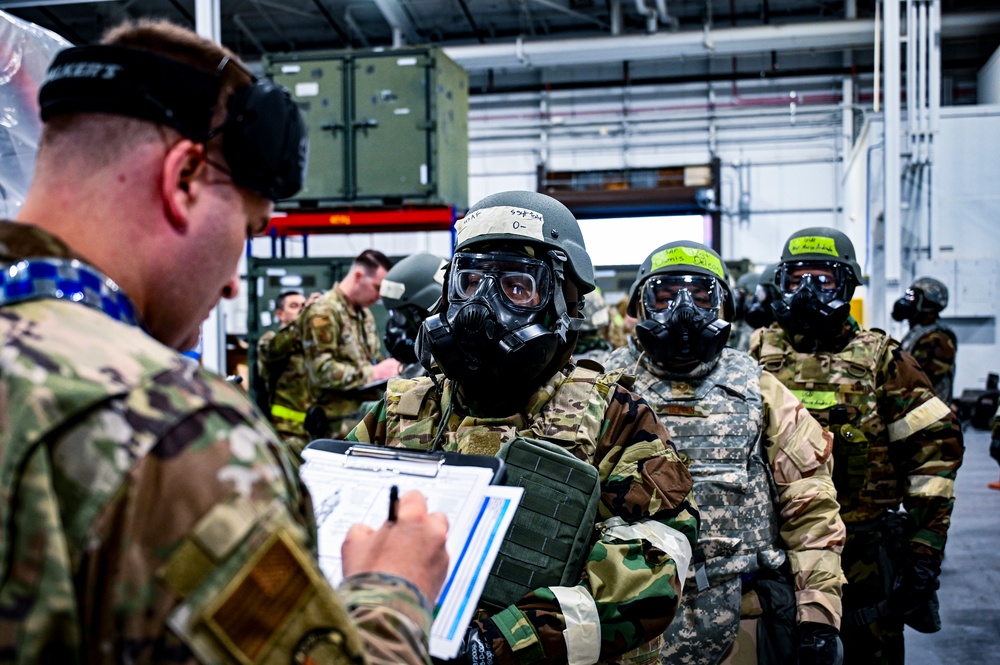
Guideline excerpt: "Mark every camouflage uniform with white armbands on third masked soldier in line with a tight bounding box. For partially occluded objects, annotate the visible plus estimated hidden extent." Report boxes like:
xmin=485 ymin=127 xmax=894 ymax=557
xmin=750 ymin=319 xmax=964 ymax=665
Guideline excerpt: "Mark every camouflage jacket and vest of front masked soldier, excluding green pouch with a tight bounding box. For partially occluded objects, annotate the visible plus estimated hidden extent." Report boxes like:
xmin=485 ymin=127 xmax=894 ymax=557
xmin=348 ymin=365 xmax=698 ymax=664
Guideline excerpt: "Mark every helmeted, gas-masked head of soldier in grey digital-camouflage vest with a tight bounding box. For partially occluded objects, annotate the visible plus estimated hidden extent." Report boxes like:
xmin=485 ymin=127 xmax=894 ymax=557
xmin=628 ymin=241 xmax=735 ymax=375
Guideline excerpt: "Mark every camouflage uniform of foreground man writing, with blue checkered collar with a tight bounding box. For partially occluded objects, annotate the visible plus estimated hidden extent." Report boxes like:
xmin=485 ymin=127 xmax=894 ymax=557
xmin=0 ymin=222 xmax=438 ymax=663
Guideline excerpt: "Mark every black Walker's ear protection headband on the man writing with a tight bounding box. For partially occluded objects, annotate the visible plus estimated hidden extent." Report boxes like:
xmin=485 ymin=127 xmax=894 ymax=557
xmin=38 ymin=45 xmax=309 ymax=200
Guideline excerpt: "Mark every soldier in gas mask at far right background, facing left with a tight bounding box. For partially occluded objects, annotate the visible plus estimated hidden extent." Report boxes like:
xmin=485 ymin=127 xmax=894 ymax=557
xmin=892 ymin=277 xmax=958 ymax=404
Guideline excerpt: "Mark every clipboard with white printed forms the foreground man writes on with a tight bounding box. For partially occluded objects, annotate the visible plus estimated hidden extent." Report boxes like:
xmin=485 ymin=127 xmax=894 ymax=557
xmin=300 ymin=439 xmax=524 ymax=659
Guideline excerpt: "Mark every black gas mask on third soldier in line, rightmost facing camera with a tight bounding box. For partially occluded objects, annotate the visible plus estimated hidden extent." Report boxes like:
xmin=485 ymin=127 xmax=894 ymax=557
xmin=771 ymin=263 xmax=851 ymax=343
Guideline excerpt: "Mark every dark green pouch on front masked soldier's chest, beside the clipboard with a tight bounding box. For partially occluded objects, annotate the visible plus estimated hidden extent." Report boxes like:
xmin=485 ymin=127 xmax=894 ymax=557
xmin=480 ymin=437 xmax=600 ymax=612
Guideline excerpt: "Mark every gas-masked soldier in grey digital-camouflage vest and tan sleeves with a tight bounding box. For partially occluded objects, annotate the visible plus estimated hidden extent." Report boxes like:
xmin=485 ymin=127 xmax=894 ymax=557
xmin=608 ymin=241 xmax=846 ymax=665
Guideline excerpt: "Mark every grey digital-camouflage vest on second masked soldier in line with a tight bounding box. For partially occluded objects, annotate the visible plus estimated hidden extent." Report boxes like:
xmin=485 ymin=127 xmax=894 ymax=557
xmin=636 ymin=348 xmax=785 ymax=588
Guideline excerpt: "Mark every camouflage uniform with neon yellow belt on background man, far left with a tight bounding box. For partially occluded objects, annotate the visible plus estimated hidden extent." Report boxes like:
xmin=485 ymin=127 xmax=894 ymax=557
xmin=257 ymin=321 xmax=309 ymax=461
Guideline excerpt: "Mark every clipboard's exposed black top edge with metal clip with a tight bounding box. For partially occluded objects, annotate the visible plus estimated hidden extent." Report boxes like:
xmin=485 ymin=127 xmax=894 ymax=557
xmin=306 ymin=439 xmax=507 ymax=485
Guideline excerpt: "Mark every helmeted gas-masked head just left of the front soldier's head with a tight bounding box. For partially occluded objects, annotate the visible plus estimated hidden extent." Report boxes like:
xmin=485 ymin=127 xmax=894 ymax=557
xmin=379 ymin=252 xmax=448 ymax=379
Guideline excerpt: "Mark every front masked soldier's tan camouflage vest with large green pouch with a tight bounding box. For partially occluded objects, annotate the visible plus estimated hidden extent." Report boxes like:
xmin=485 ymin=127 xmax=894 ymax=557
xmin=386 ymin=367 xmax=620 ymax=611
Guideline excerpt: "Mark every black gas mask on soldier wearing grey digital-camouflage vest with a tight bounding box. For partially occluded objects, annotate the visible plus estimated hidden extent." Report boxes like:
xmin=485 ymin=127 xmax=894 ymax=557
xmin=635 ymin=275 xmax=731 ymax=374
